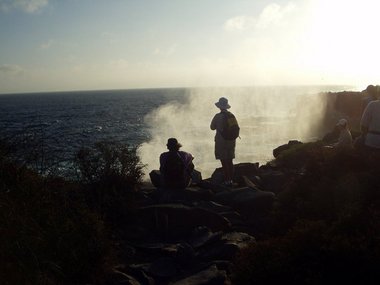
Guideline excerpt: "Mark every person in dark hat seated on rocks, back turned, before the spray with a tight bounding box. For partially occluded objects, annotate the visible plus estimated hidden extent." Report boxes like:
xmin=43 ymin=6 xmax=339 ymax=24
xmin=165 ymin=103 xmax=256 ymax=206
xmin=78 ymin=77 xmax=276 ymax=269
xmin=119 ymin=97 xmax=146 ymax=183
xmin=160 ymin=138 xmax=194 ymax=189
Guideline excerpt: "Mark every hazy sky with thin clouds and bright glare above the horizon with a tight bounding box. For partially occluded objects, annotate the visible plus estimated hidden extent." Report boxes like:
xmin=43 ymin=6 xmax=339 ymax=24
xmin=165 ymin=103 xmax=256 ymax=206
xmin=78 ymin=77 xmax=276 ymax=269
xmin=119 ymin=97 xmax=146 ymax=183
xmin=0 ymin=0 xmax=380 ymax=94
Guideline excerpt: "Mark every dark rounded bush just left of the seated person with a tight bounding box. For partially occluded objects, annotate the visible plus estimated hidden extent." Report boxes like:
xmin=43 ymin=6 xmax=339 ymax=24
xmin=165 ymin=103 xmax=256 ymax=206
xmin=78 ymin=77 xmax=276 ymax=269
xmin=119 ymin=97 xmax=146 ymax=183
xmin=75 ymin=142 xmax=144 ymax=224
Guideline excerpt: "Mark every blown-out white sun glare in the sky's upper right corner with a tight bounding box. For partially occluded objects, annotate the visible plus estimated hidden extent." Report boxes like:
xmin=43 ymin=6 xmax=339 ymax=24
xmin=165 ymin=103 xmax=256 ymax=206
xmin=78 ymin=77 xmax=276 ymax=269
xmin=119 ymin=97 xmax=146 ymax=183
xmin=309 ymin=0 xmax=380 ymax=84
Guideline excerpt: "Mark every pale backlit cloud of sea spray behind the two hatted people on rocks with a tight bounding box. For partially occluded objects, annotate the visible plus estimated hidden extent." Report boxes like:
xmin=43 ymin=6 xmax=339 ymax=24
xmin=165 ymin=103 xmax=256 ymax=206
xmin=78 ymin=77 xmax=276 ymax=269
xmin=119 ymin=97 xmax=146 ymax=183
xmin=139 ymin=86 xmax=332 ymax=178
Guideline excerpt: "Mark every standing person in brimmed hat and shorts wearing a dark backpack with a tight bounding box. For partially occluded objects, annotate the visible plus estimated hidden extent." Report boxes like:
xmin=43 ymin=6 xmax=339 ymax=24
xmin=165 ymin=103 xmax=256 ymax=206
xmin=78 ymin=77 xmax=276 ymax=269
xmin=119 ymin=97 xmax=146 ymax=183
xmin=210 ymin=97 xmax=240 ymax=186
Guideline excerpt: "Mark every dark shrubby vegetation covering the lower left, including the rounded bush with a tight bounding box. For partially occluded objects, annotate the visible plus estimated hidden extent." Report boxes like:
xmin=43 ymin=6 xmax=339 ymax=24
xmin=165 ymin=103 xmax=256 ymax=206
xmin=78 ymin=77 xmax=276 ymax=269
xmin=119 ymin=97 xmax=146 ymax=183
xmin=0 ymin=137 xmax=143 ymax=284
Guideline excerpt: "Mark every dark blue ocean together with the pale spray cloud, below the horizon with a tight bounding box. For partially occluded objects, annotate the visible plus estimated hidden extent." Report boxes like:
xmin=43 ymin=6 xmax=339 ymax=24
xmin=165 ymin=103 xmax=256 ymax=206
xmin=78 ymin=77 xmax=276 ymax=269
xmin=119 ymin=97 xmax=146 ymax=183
xmin=0 ymin=86 xmax=349 ymax=177
